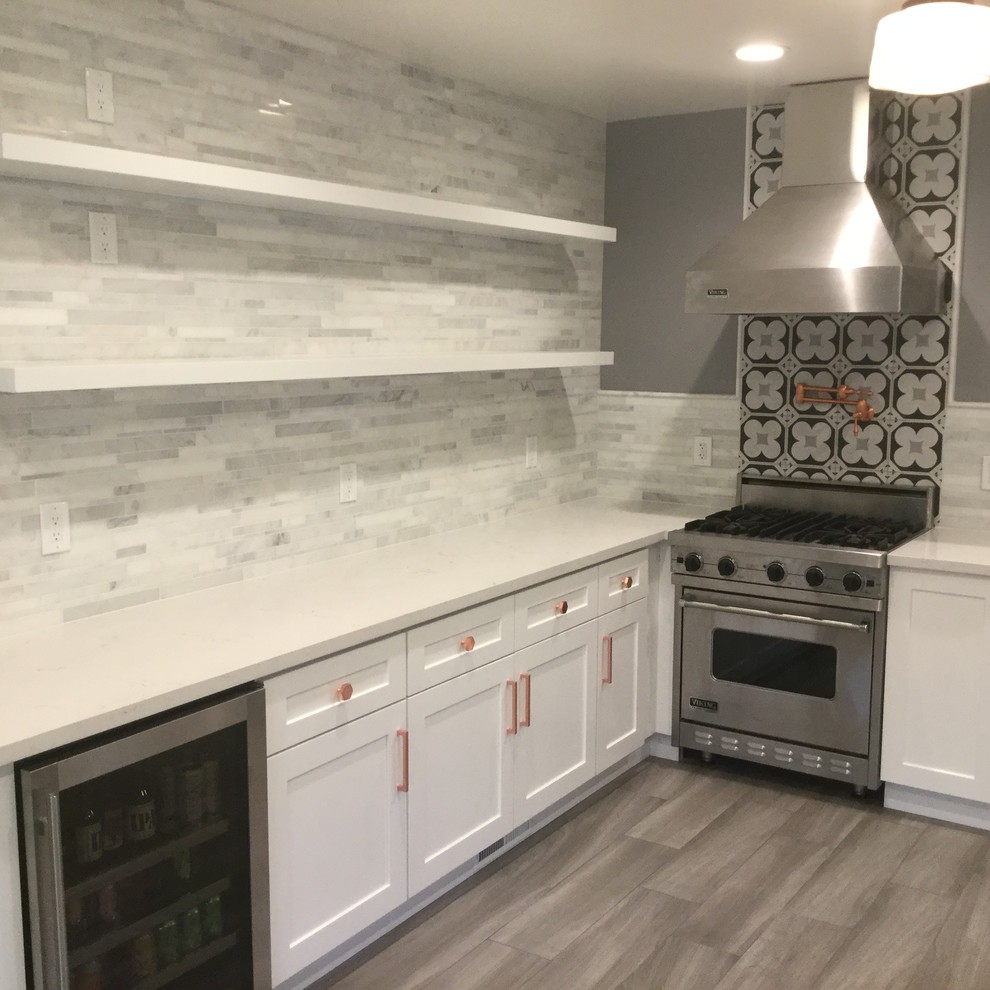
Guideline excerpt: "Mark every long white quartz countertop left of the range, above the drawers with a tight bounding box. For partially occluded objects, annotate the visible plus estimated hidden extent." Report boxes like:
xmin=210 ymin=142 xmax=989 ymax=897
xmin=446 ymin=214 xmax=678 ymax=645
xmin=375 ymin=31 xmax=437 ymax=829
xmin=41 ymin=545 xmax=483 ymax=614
xmin=0 ymin=499 xmax=700 ymax=766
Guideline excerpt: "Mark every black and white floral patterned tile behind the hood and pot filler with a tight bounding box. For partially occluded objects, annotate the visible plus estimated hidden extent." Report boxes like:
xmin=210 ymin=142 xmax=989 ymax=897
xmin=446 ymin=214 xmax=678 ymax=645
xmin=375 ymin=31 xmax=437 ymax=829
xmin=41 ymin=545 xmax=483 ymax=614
xmin=740 ymin=94 xmax=967 ymax=504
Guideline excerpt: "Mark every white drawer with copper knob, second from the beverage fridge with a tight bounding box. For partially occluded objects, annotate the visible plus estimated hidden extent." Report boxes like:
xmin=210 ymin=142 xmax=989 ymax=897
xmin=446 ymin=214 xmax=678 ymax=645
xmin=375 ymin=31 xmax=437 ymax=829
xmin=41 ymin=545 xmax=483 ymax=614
xmin=408 ymin=598 xmax=515 ymax=694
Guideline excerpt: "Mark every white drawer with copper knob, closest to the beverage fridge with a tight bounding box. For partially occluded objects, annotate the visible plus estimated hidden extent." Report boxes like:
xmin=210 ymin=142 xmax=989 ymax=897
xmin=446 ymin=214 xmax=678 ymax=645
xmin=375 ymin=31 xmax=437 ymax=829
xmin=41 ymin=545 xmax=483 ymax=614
xmin=265 ymin=633 xmax=406 ymax=754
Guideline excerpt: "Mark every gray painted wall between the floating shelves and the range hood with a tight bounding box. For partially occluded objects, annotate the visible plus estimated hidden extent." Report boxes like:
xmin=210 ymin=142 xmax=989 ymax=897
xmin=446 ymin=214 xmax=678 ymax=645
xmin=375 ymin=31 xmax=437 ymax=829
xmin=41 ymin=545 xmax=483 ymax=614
xmin=602 ymin=109 xmax=746 ymax=395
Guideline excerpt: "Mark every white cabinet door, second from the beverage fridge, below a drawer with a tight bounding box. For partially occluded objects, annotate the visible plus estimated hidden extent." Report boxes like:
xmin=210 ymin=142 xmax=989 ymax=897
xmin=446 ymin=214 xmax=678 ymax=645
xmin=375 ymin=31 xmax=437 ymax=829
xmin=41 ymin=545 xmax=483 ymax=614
xmin=407 ymin=657 xmax=517 ymax=896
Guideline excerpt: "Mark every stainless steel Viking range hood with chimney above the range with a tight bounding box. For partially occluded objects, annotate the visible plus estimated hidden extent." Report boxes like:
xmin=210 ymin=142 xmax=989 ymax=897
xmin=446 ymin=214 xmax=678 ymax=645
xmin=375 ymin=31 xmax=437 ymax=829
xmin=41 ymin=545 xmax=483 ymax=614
xmin=685 ymin=80 xmax=945 ymax=315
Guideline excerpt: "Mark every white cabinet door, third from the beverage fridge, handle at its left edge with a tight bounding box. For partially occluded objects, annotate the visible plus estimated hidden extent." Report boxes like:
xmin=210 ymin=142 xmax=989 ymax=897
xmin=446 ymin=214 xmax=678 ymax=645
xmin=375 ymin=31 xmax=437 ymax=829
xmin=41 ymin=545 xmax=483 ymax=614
xmin=513 ymin=622 xmax=597 ymax=824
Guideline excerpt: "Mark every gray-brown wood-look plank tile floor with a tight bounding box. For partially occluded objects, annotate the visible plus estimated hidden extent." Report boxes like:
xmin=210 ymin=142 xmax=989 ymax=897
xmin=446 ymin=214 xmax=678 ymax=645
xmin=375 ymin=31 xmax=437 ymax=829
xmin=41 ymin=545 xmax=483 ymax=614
xmin=317 ymin=760 xmax=990 ymax=990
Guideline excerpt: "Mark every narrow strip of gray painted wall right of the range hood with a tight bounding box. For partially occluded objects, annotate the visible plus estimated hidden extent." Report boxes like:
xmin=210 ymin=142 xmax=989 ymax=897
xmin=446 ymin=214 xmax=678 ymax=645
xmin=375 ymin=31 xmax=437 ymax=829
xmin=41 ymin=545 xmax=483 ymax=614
xmin=955 ymin=86 xmax=990 ymax=402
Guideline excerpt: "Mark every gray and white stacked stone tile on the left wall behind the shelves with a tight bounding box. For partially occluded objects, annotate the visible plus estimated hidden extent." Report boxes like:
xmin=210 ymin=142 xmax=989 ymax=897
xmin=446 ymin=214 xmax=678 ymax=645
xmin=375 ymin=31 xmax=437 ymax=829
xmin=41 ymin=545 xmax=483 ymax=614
xmin=0 ymin=0 xmax=605 ymax=633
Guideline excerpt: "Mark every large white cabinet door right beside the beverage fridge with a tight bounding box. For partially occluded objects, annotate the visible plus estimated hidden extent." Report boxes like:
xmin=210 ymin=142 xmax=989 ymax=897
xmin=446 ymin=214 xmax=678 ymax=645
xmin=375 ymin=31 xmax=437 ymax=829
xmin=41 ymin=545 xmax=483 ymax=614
xmin=268 ymin=702 xmax=406 ymax=984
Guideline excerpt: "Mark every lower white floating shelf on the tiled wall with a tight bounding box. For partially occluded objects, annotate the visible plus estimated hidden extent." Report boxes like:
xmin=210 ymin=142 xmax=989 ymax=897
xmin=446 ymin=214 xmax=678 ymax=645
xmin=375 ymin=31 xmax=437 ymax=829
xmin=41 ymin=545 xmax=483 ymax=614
xmin=0 ymin=351 xmax=614 ymax=393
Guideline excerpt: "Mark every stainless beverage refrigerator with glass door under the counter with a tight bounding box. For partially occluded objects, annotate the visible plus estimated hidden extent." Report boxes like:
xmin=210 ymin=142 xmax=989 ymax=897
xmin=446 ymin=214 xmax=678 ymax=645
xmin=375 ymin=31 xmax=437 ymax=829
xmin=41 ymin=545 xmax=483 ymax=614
xmin=17 ymin=687 xmax=271 ymax=990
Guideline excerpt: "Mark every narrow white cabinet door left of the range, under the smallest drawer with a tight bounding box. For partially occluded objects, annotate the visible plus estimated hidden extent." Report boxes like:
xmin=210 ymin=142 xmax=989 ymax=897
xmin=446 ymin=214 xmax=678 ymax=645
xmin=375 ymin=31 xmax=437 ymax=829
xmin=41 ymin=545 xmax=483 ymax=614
xmin=596 ymin=600 xmax=651 ymax=773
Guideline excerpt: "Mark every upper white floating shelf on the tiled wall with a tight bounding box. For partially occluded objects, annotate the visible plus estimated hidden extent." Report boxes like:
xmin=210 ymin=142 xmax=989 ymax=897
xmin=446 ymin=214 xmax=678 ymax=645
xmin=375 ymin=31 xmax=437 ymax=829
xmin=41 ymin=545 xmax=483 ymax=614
xmin=0 ymin=133 xmax=615 ymax=242
